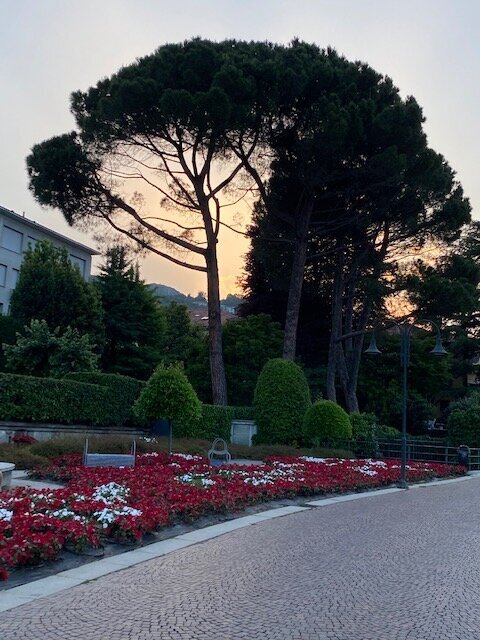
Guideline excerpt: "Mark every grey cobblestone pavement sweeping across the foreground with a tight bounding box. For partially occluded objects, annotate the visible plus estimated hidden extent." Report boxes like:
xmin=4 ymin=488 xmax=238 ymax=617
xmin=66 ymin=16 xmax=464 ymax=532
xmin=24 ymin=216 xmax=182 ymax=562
xmin=0 ymin=479 xmax=480 ymax=640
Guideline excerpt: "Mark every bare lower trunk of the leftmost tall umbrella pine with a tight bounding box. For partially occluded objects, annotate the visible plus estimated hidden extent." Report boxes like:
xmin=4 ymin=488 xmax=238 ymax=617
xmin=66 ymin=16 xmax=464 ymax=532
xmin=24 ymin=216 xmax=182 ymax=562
xmin=205 ymin=242 xmax=228 ymax=405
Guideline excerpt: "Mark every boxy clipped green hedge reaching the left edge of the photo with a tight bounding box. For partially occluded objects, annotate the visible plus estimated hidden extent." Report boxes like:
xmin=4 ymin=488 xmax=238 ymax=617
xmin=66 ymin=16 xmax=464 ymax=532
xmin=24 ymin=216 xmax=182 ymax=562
xmin=0 ymin=373 xmax=112 ymax=425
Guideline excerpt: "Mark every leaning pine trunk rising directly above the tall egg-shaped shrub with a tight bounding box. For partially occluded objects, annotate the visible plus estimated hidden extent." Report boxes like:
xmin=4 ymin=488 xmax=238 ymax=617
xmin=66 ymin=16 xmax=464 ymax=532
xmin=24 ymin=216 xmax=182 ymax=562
xmin=283 ymin=198 xmax=313 ymax=360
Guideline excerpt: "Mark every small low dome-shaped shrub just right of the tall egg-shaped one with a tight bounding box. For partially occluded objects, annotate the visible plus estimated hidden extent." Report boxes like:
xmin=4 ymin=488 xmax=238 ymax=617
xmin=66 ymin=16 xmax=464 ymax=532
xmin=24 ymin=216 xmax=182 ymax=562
xmin=303 ymin=400 xmax=352 ymax=446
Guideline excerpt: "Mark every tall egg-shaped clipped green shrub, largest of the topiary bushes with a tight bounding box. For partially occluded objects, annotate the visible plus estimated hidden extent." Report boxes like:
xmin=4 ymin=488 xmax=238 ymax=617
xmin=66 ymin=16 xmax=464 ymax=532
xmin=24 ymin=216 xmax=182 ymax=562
xmin=253 ymin=358 xmax=311 ymax=444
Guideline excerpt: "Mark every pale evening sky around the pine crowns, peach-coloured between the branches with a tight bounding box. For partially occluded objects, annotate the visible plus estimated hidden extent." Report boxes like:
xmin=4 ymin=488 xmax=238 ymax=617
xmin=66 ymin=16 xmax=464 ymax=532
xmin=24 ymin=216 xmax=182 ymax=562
xmin=0 ymin=0 xmax=480 ymax=295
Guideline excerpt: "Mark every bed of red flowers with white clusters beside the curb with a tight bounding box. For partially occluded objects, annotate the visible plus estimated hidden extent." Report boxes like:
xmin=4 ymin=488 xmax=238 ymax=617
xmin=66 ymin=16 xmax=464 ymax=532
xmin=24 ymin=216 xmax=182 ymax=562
xmin=0 ymin=454 xmax=464 ymax=579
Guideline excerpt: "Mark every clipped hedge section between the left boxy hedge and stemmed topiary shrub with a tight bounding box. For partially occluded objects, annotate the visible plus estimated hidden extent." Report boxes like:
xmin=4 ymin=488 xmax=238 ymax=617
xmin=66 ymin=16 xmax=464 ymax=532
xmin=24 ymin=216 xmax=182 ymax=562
xmin=64 ymin=371 xmax=146 ymax=427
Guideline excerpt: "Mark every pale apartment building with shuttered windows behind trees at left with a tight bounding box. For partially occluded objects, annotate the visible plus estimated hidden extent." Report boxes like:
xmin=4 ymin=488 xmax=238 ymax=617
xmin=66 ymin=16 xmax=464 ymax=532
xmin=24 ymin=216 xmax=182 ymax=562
xmin=0 ymin=206 xmax=99 ymax=314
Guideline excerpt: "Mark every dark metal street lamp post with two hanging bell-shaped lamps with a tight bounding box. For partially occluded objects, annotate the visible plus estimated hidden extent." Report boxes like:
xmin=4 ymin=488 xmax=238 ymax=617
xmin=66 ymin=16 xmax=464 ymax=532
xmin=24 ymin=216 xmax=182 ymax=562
xmin=365 ymin=320 xmax=448 ymax=489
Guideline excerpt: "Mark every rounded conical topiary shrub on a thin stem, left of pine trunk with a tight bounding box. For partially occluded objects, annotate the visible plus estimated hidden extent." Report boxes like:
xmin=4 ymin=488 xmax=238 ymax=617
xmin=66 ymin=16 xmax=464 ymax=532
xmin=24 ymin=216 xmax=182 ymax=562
xmin=133 ymin=365 xmax=202 ymax=424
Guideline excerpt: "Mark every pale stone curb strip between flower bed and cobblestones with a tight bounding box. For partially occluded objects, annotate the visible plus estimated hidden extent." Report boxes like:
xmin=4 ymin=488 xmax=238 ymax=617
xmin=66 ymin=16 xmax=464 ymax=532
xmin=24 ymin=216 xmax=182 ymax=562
xmin=0 ymin=472 xmax=472 ymax=612
